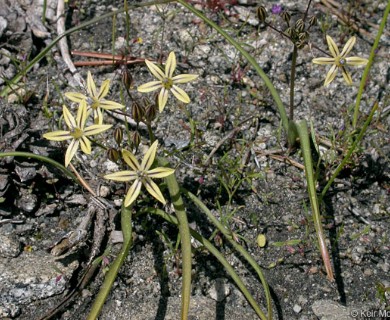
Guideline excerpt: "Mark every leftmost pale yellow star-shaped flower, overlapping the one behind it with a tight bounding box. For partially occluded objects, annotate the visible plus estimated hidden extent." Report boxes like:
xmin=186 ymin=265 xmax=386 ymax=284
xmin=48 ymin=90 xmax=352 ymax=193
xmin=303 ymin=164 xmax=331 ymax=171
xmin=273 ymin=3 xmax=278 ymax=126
xmin=43 ymin=100 xmax=111 ymax=167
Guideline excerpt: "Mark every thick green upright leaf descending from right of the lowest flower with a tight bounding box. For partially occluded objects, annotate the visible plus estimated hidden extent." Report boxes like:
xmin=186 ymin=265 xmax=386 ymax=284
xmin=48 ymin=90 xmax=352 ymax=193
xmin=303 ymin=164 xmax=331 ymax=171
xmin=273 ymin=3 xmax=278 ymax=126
xmin=158 ymin=158 xmax=192 ymax=320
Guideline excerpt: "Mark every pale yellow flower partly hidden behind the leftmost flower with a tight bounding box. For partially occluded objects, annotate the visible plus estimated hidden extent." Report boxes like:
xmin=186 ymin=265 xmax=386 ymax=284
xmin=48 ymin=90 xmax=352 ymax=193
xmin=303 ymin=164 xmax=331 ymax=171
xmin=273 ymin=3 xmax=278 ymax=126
xmin=65 ymin=71 xmax=125 ymax=124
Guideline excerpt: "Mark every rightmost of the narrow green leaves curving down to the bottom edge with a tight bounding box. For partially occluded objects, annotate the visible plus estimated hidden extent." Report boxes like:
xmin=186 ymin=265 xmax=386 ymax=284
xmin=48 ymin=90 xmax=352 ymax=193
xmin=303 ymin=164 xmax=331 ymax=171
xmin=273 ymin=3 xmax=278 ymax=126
xmin=181 ymin=188 xmax=272 ymax=319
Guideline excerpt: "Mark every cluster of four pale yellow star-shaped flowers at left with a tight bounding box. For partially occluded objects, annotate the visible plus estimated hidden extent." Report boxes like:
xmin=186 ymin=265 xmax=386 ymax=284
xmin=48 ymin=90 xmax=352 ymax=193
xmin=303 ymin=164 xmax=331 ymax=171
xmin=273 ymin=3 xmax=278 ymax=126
xmin=43 ymin=52 xmax=198 ymax=206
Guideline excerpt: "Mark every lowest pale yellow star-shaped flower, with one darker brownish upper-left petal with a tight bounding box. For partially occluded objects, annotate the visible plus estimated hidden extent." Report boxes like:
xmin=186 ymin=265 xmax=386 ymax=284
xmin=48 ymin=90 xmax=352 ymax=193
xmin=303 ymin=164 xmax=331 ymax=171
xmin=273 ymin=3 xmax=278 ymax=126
xmin=104 ymin=141 xmax=175 ymax=207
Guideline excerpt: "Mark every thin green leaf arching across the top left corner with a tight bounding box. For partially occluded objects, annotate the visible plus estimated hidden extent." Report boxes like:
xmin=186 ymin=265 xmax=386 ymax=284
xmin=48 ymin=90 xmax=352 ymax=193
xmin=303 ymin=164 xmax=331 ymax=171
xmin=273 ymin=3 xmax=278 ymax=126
xmin=0 ymin=0 xmax=174 ymax=97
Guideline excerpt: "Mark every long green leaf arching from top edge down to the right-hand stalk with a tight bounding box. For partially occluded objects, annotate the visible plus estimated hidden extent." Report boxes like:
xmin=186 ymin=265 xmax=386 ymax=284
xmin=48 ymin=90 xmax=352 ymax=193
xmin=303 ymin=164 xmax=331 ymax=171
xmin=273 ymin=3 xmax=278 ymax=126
xmin=176 ymin=0 xmax=288 ymax=134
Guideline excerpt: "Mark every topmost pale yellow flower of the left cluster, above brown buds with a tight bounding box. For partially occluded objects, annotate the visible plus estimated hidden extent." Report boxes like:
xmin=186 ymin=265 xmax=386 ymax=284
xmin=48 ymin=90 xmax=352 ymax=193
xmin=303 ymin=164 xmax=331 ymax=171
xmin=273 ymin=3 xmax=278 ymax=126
xmin=138 ymin=52 xmax=198 ymax=112
